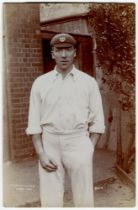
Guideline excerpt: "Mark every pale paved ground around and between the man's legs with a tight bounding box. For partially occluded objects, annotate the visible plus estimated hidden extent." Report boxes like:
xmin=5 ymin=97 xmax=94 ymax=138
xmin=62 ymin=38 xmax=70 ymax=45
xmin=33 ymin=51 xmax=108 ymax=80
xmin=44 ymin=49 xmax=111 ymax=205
xmin=3 ymin=150 xmax=135 ymax=207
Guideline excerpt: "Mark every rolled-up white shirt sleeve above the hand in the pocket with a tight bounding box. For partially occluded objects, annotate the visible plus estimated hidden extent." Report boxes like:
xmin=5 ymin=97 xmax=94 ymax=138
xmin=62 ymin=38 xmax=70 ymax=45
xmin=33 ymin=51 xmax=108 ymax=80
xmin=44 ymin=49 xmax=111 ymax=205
xmin=89 ymin=79 xmax=105 ymax=133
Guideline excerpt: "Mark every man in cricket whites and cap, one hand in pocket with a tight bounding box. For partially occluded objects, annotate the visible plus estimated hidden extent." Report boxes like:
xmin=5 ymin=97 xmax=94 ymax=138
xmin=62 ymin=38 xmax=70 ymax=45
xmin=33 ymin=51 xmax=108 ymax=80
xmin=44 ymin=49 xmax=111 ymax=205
xmin=27 ymin=34 xmax=104 ymax=207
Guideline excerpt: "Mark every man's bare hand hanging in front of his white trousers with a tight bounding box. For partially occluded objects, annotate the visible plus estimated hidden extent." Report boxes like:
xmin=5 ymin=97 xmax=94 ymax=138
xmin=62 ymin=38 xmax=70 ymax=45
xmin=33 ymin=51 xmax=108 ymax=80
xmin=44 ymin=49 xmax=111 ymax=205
xmin=39 ymin=153 xmax=57 ymax=172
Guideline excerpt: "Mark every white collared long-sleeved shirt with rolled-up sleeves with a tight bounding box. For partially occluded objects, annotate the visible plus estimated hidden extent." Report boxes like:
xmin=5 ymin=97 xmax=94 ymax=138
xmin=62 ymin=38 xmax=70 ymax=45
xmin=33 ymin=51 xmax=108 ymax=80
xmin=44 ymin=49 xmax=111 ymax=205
xmin=26 ymin=66 xmax=105 ymax=134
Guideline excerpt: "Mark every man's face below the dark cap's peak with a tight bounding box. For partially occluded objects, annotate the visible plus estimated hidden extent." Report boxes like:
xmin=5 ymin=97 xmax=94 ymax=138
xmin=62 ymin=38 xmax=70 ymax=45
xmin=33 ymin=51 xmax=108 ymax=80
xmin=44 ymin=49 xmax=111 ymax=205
xmin=52 ymin=46 xmax=76 ymax=71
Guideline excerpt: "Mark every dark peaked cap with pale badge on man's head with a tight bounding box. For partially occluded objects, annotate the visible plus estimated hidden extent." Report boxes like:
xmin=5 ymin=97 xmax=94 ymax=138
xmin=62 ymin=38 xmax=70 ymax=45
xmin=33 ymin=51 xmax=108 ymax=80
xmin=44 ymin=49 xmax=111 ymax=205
xmin=50 ymin=34 xmax=77 ymax=47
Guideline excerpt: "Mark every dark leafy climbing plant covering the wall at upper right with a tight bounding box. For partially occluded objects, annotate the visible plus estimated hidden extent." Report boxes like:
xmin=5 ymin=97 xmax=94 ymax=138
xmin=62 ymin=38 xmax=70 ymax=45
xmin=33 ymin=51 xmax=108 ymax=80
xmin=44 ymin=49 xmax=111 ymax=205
xmin=89 ymin=3 xmax=135 ymax=110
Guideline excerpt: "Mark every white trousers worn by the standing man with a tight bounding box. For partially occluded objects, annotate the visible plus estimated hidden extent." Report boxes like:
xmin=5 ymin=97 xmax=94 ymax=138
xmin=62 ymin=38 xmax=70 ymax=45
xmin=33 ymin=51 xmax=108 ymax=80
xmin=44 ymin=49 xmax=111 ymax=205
xmin=39 ymin=130 xmax=94 ymax=207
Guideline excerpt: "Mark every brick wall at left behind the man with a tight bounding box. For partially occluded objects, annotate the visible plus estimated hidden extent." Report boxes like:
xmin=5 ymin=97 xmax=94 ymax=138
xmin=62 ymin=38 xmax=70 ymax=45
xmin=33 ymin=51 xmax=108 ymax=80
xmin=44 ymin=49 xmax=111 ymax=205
xmin=4 ymin=3 xmax=43 ymax=160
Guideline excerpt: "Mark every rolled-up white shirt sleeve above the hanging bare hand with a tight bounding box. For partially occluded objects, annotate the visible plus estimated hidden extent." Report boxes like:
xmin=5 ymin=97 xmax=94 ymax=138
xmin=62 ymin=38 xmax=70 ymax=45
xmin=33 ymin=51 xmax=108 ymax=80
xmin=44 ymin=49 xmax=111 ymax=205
xmin=26 ymin=81 xmax=42 ymax=135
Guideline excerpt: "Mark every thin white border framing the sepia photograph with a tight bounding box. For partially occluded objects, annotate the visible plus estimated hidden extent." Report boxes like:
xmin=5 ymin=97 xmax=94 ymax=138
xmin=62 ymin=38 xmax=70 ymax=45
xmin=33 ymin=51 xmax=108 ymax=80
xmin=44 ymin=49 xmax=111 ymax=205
xmin=0 ymin=0 xmax=138 ymax=210
